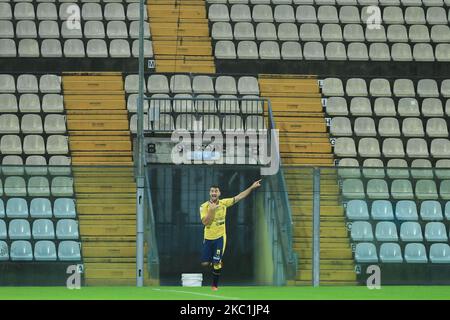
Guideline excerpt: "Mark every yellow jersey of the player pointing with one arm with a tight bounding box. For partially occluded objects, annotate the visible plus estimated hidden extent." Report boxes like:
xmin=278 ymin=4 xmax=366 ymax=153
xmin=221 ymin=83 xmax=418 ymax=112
xmin=200 ymin=198 xmax=234 ymax=240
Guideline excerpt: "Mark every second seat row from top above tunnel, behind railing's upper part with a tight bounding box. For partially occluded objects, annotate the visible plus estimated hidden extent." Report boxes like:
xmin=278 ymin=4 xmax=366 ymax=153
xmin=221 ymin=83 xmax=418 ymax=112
xmin=127 ymin=93 xmax=264 ymax=114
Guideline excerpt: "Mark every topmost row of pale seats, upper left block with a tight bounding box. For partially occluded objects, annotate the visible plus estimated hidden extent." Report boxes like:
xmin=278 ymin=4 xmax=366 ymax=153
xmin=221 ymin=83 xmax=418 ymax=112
xmin=0 ymin=1 xmax=147 ymax=20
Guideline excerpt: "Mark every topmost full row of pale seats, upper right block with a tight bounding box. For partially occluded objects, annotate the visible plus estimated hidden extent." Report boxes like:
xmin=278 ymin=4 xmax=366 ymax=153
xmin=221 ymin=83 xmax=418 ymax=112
xmin=208 ymin=4 xmax=450 ymax=24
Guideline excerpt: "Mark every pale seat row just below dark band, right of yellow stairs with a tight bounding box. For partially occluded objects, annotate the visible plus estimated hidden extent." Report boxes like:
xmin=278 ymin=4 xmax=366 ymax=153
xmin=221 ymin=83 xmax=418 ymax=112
xmin=322 ymin=78 xmax=450 ymax=98
